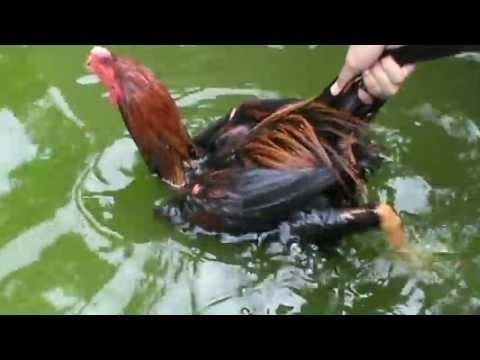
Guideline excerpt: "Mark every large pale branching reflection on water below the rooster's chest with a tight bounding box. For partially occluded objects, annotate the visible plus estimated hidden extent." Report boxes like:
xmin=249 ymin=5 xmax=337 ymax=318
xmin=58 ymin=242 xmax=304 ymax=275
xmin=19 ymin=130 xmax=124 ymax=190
xmin=0 ymin=107 xmax=324 ymax=314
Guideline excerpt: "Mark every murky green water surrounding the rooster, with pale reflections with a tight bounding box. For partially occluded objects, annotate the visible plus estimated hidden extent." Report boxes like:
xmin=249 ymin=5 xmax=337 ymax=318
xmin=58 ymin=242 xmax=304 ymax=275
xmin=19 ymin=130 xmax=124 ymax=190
xmin=0 ymin=46 xmax=480 ymax=314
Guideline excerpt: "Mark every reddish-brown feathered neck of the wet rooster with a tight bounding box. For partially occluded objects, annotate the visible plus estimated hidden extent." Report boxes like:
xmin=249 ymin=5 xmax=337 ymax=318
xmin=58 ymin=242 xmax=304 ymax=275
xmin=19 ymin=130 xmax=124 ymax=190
xmin=114 ymin=56 xmax=196 ymax=186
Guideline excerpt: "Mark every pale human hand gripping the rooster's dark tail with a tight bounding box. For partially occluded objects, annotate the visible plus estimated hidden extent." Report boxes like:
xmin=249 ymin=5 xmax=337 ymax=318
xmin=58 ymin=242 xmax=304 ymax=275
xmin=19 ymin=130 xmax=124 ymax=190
xmin=330 ymin=45 xmax=415 ymax=104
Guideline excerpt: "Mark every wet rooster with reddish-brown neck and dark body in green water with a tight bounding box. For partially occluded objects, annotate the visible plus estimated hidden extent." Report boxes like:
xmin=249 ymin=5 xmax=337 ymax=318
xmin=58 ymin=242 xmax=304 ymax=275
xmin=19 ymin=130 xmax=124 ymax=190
xmin=87 ymin=47 xmax=406 ymax=250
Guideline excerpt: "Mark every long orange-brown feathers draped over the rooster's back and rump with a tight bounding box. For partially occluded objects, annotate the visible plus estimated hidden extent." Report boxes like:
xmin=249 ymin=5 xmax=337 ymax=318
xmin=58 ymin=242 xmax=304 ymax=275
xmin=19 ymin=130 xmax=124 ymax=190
xmin=233 ymin=99 xmax=367 ymax=188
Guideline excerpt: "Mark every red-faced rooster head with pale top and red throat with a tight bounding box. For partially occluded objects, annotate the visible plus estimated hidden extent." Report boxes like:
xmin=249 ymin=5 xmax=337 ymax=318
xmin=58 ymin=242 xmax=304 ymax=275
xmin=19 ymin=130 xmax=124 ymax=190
xmin=86 ymin=46 xmax=123 ymax=105
